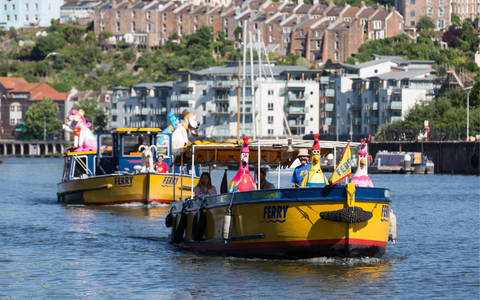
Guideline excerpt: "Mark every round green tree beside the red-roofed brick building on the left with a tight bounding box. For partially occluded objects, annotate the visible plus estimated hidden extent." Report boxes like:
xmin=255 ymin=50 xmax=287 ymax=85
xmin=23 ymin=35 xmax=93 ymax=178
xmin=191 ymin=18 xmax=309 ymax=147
xmin=25 ymin=97 xmax=62 ymax=137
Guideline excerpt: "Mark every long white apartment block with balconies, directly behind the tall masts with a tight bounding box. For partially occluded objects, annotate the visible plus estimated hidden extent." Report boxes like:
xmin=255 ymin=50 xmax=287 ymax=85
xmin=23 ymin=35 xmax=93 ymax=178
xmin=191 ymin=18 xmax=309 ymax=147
xmin=111 ymin=62 xmax=320 ymax=138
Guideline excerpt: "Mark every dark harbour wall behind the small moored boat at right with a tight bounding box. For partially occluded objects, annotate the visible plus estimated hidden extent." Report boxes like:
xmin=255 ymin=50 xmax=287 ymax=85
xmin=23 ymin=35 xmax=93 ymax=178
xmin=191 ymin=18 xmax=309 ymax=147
xmin=369 ymin=142 xmax=480 ymax=175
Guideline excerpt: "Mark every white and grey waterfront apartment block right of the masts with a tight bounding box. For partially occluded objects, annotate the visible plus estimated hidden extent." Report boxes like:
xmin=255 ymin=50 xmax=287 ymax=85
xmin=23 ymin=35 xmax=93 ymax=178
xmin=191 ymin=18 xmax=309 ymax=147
xmin=321 ymin=55 xmax=440 ymax=135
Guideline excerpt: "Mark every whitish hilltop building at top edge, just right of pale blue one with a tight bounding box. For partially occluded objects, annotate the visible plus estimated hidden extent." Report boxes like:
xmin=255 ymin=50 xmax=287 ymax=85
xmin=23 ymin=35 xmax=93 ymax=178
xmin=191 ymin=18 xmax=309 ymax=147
xmin=60 ymin=0 xmax=102 ymax=25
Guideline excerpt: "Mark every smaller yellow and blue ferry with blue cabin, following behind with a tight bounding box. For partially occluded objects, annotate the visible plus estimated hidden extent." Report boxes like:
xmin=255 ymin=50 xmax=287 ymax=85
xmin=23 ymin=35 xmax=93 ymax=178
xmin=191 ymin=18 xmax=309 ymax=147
xmin=57 ymin=128 xmax=199 ymax=205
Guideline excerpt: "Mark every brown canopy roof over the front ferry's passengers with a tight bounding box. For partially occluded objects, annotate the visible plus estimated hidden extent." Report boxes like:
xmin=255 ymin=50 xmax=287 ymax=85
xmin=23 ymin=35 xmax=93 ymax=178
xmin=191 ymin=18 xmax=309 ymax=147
xmin=174 ymin=139 xmax=360 ymax=168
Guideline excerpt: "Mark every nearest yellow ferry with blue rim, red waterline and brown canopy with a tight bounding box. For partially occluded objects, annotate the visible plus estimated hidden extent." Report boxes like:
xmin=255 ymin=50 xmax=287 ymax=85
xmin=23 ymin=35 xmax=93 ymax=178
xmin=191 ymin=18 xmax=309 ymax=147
xmin=165 ymin=141 xmax=396 ymax=259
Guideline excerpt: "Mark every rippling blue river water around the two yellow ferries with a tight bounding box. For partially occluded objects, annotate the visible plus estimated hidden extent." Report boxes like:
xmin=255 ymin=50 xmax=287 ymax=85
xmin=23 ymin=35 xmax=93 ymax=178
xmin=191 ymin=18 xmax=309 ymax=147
xmin=0 ymin=158 xmax=480 ymax=299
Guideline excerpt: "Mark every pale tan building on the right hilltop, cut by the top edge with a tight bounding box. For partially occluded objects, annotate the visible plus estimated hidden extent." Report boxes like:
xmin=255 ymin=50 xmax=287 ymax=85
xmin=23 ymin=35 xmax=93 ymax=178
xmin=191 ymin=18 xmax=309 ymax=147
xmin=395 ymin=0 xmax=452 ymax=31
